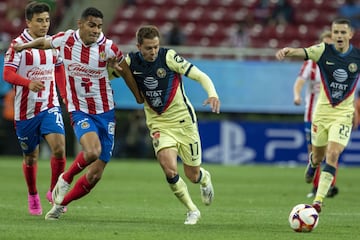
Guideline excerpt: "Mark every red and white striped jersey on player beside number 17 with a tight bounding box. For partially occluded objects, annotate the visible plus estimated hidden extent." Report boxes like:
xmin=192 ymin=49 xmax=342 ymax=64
xmin=51 ymin=30 xmax=124 ymax=114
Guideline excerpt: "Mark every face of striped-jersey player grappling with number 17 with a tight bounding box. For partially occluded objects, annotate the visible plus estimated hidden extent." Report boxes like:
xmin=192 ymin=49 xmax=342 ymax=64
xmin=78 ymin=16 xmax=103 ymax=45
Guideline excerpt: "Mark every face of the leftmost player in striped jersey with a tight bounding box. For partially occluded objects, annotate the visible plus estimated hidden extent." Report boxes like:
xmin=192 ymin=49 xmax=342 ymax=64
xmin=26 ymin=12 xmax=50 ymax=38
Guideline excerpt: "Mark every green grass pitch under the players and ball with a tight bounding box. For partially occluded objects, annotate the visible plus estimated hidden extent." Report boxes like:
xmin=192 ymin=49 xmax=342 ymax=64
xmin=0 ymin=156 xmax=360 ymax=240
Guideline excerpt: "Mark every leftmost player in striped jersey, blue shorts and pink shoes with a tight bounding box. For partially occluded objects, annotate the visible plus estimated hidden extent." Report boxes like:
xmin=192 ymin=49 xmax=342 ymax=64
xmin=4 ymin=2 xmax=66 ymax=215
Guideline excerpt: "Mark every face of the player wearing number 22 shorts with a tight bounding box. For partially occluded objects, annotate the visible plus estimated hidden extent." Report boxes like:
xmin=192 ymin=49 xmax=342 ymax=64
xmin=331 ymin=23 xmax=353 ymax=52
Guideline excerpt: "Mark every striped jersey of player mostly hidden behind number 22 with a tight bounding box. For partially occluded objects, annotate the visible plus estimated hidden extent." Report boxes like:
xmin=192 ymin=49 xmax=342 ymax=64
xmin=299 ymin=60 xmax=321 ymax=122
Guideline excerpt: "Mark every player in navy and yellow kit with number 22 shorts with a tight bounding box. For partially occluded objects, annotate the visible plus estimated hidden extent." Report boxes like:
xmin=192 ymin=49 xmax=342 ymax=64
xmin=276 ymin=19 xmax=360 ymax=212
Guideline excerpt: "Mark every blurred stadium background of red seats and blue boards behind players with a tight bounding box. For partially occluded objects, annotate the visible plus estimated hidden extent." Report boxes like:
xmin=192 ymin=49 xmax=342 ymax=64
xmin=0 ymin=0 xmax=360 ymax=165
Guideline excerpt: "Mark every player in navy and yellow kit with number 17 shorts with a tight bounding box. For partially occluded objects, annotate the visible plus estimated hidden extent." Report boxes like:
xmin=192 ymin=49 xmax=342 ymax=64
xmin=116 ymin=25 xmax=220 ymax=225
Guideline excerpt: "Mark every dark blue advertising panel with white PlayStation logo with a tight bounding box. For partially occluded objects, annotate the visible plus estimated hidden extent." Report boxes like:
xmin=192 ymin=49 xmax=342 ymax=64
xmin=199 ymin=121 xmax=360 ymax=165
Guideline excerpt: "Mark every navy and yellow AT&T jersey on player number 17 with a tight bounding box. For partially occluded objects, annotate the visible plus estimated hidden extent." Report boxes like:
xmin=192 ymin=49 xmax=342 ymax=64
xmin=126 ymin=48 xmax=217 ymax=129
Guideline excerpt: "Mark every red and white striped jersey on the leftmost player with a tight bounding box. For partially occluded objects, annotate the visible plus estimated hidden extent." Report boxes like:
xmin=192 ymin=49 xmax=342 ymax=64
xmin=4 ymin=29 xmax=62 ymax=120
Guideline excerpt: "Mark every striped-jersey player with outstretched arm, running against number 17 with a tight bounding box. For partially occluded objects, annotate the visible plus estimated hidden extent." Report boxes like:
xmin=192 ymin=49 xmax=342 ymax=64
xmin=17 ymin=7 xmax=143 ymax=220
